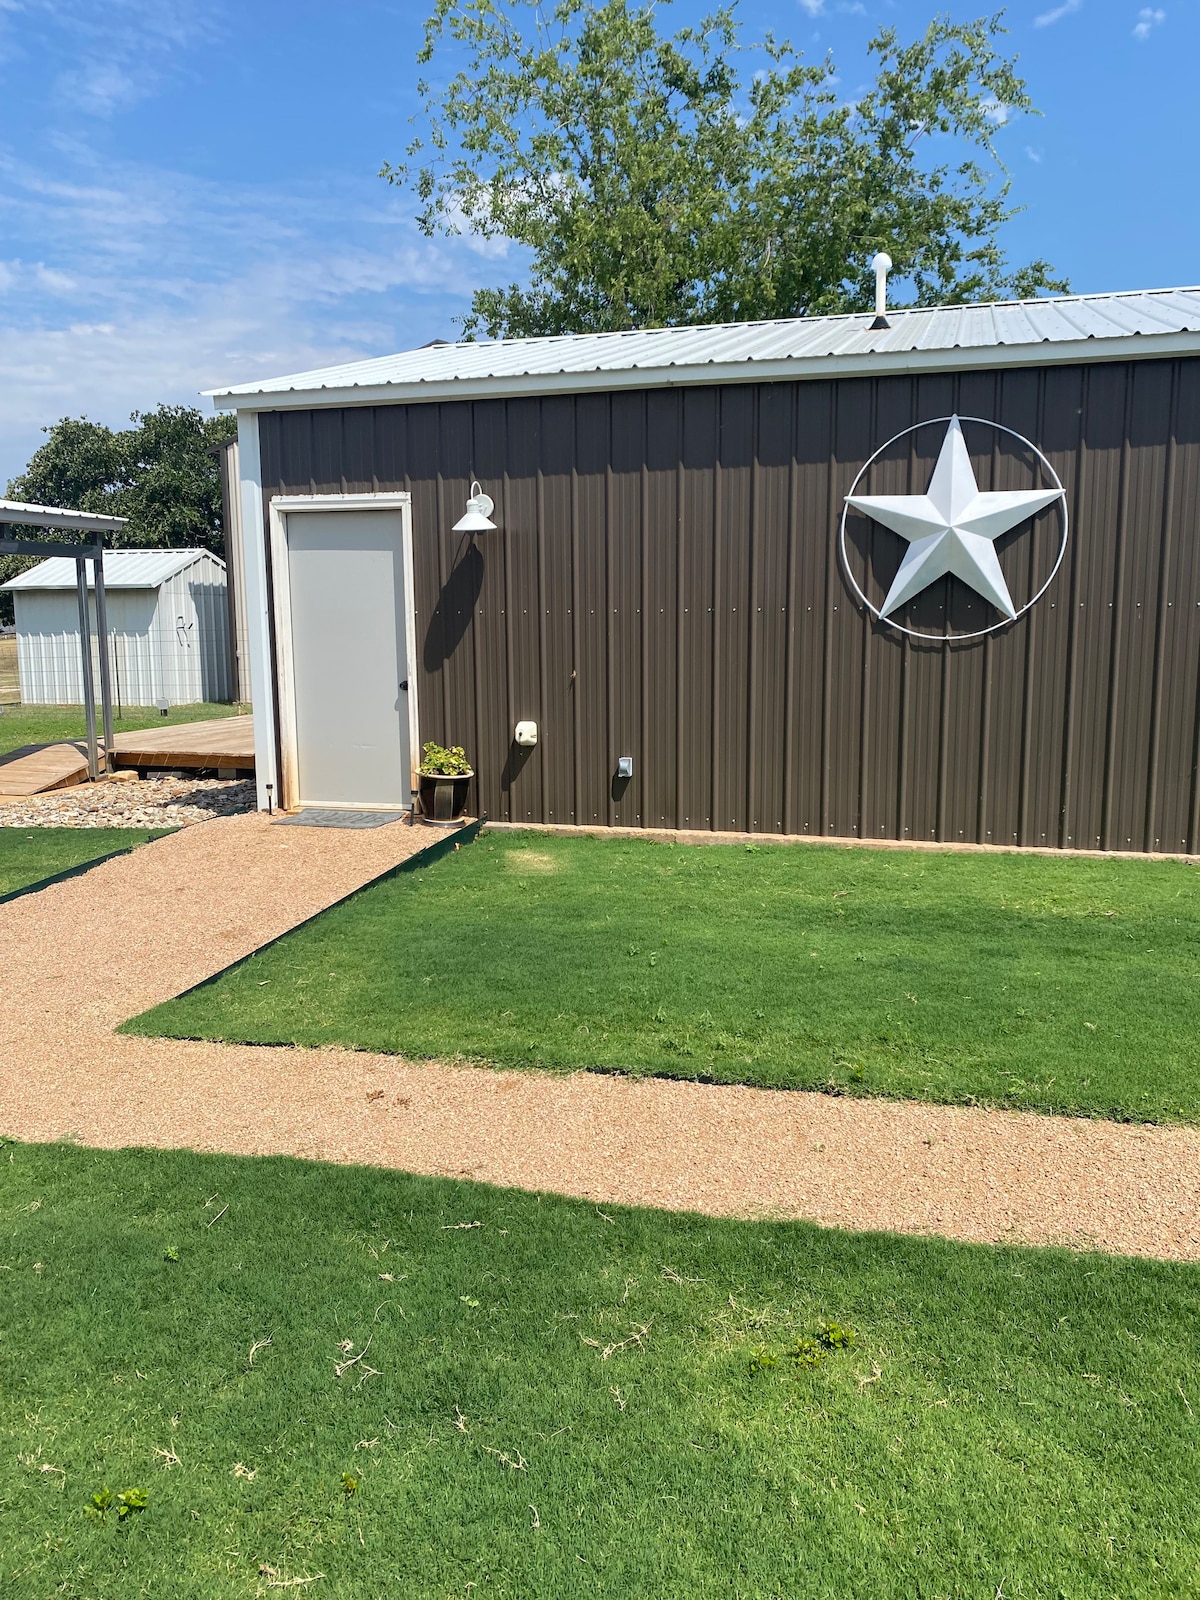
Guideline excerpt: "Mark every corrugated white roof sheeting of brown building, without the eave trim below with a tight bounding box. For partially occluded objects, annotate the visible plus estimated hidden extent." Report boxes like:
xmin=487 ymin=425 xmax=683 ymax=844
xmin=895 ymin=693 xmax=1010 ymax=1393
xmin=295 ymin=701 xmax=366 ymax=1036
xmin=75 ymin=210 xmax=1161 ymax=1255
xmin=210 ymin=288 xmax=1200 ymax=403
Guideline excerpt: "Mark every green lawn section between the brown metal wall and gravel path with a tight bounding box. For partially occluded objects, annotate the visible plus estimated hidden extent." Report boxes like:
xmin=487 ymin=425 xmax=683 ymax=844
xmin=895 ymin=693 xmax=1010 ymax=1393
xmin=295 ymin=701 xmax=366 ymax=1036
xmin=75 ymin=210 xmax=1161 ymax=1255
xmin=126 ymin=834 xmax=1200 ymax=1120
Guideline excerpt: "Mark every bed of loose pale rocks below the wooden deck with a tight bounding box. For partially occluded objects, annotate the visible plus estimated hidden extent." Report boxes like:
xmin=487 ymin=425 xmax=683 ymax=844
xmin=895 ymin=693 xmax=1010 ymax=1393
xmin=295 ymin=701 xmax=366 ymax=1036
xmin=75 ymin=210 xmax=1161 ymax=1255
xmin=0 ymin=778 xmax=254 ymax=827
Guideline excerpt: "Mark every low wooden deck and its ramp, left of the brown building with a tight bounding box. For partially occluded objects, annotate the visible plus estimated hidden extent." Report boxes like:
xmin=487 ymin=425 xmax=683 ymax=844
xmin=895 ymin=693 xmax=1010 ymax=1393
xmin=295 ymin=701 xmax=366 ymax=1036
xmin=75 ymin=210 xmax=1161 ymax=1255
xmin=0 ymin=717 xmax=254 ymax=800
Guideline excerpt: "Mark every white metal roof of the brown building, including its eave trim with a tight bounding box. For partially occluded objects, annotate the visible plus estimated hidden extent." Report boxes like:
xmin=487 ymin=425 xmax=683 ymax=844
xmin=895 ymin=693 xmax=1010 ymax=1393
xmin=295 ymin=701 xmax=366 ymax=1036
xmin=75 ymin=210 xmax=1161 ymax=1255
xmin=206 ymin=288 xmax=1200 ymax=410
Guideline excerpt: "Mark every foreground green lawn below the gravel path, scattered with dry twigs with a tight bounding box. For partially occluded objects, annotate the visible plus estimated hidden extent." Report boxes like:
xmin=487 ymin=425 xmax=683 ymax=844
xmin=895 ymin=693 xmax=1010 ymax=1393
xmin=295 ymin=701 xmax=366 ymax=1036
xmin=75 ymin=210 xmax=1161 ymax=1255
xmin=0 ymin=1146 xmax=1200 ymax=1600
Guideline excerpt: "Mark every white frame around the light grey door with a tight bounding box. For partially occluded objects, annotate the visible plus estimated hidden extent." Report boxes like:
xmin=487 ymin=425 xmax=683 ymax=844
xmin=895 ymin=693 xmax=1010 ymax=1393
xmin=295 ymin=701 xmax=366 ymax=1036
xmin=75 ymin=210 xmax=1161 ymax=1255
xmin=270 ymin=491 xmax=421 ymax=811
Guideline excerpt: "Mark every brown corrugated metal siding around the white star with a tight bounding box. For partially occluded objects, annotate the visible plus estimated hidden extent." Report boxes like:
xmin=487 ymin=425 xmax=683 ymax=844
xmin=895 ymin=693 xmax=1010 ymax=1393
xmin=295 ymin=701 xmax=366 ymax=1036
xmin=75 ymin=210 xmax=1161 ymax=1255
xmin=259 ymin=358 xmax=1200 ymax=851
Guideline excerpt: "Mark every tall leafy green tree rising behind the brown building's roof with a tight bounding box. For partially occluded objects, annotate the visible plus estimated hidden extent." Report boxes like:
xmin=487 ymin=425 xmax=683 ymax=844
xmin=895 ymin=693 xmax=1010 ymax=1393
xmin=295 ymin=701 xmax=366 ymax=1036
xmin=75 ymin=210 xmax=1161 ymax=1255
xmin=381 ymin=0 xmax=1067 ymax=338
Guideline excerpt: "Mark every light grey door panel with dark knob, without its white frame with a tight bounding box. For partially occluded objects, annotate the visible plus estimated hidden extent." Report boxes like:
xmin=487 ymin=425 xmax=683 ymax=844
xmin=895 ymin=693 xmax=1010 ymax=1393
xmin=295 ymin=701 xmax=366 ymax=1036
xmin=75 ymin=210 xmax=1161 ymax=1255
xmin=286 ymin=509 xmax=411 ymax=810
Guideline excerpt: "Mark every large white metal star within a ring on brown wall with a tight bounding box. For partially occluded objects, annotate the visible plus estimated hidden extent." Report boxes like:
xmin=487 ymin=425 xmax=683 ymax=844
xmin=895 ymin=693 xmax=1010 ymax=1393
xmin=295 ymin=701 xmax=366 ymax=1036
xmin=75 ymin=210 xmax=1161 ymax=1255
xmin=842 ymin=416 xmax=1067 ymax=638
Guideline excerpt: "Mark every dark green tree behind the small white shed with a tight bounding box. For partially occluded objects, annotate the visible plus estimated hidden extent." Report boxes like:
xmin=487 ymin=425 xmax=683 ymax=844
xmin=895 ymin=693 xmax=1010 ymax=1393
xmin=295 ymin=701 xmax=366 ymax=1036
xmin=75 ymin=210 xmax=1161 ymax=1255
xmin=0 ymin=405 xmax=237 ymax=606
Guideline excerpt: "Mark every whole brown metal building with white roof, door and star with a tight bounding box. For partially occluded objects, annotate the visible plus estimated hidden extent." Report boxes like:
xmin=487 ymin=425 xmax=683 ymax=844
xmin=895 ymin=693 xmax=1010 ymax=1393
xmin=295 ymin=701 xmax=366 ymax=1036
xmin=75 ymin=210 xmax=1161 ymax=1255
xmin=214 ymin=290 xmax=1200 ymax=851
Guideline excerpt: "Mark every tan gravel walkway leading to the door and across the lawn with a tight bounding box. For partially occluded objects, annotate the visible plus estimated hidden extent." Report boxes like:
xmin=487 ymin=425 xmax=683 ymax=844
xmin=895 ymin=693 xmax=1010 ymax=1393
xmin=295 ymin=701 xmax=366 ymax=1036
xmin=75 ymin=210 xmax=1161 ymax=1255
xmin=0 ymin=814 xmax=1200 ymax=1261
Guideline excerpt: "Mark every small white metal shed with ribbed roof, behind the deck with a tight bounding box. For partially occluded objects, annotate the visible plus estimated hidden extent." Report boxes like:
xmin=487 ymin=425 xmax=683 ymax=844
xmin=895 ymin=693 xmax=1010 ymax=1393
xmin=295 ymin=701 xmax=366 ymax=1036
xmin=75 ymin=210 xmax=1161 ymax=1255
xmin=3 ymin=550 xmax=232 ymax=706
